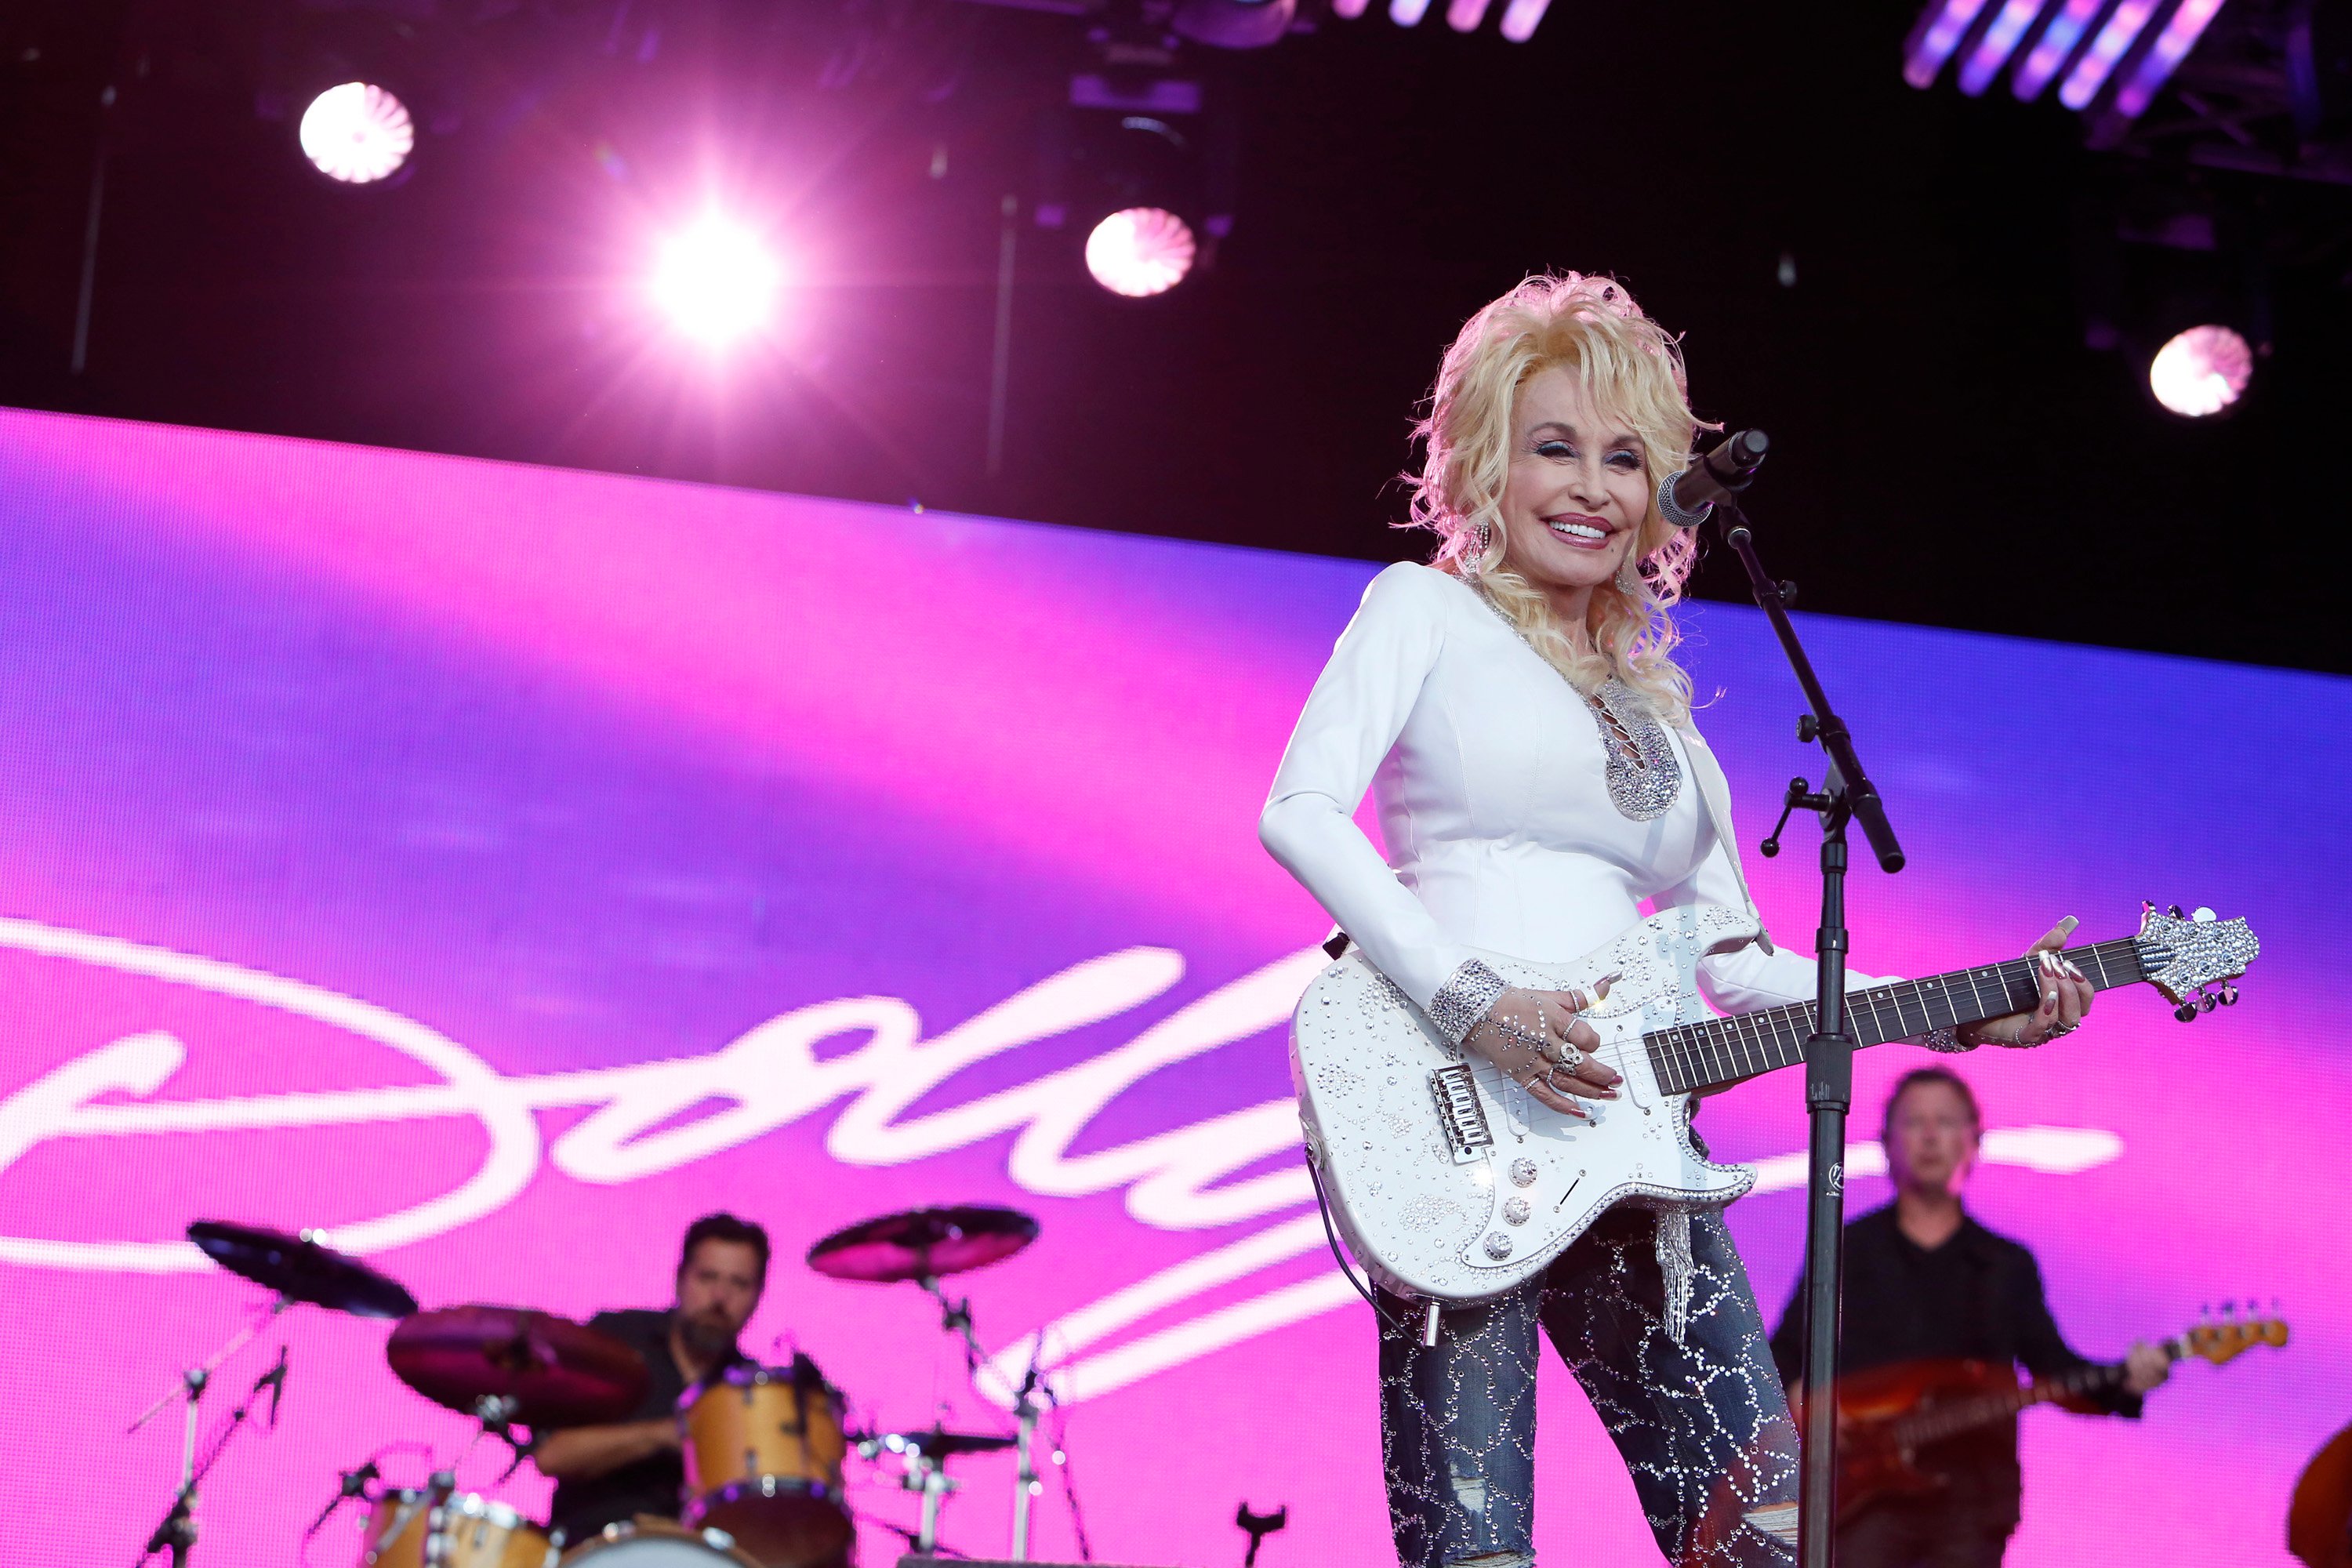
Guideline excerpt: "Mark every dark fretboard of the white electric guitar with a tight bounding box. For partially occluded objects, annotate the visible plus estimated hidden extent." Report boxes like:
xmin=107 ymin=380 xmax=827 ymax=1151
xmin=1642 ymin=938 xmax=2147 ymax=1093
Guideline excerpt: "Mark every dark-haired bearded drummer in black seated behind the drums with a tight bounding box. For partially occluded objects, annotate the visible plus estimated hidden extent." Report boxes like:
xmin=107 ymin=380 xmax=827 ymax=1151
xmin=532 ymin=1213 xmax=816 ymax=1544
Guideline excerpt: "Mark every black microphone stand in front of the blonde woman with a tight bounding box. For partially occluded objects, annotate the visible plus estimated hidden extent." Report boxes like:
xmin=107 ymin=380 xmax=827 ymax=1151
xmin=1717 ymin=437 xmax=1903 ymax=1568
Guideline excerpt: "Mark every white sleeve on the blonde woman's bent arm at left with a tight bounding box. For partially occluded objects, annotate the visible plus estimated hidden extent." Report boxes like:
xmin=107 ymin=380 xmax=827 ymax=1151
xmin=1258 ymin=564 xmax=1470 ymax=1011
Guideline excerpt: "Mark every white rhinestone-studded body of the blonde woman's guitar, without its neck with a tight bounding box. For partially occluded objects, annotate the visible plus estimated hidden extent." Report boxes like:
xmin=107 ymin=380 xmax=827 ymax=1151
xmin=1291 ymin=905 xmax=1757 ymax=1302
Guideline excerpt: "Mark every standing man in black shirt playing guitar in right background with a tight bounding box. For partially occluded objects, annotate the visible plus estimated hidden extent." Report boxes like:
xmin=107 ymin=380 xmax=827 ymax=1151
xmin=1771 ymin=1067 xmax=2169 ymax=1568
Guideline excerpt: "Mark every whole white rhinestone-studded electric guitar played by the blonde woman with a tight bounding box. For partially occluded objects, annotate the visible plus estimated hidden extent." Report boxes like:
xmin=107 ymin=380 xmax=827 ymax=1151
xmin=1291 ymin=905 xmax=2260 ymax=1302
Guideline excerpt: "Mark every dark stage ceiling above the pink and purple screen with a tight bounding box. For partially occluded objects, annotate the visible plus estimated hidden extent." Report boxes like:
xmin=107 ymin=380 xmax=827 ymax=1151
xmin=0 ymin=0 xmax=2352 ymax=667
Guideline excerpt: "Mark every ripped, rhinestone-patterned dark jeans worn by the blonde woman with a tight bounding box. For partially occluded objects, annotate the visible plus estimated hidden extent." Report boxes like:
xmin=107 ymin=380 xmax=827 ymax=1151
xmin=1381 ymin=1206 xmax=1797 ymax=1568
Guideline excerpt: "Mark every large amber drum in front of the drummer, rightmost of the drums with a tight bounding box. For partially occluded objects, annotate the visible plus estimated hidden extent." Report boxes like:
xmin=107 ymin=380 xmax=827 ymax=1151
xmin=677 ymin=1366 xmax=856 ymax=1568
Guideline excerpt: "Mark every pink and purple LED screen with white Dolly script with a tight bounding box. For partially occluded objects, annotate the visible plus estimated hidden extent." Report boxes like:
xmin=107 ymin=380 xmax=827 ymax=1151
xmin=0 ymin=414 xmax=2352 ymax=1568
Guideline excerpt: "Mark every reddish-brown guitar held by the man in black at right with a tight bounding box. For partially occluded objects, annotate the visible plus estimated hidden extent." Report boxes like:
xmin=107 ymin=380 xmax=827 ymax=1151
xmin=1837 ymin=1319 xmax=2286 ymax=1523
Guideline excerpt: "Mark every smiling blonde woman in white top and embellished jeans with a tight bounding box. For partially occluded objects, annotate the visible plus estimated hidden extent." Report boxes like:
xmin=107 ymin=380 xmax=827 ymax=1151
xmin=1258 ymin=273 xmax=2091 ymax=1568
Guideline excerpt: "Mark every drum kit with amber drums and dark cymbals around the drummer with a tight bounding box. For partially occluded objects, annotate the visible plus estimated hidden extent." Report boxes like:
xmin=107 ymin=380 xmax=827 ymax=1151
xmin=132 ymin=1206 xmax=1058 ymax=1568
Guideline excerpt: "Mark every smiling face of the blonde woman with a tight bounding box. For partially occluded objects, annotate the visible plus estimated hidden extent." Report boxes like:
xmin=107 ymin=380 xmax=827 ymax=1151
xmin=1503 ymin=365 xmax=1651 ymax=626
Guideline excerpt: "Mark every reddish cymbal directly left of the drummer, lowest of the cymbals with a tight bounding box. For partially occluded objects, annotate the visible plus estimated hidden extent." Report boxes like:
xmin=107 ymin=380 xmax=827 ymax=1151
xmin=383 ymin=1307 xmax=649 ymax=1427
